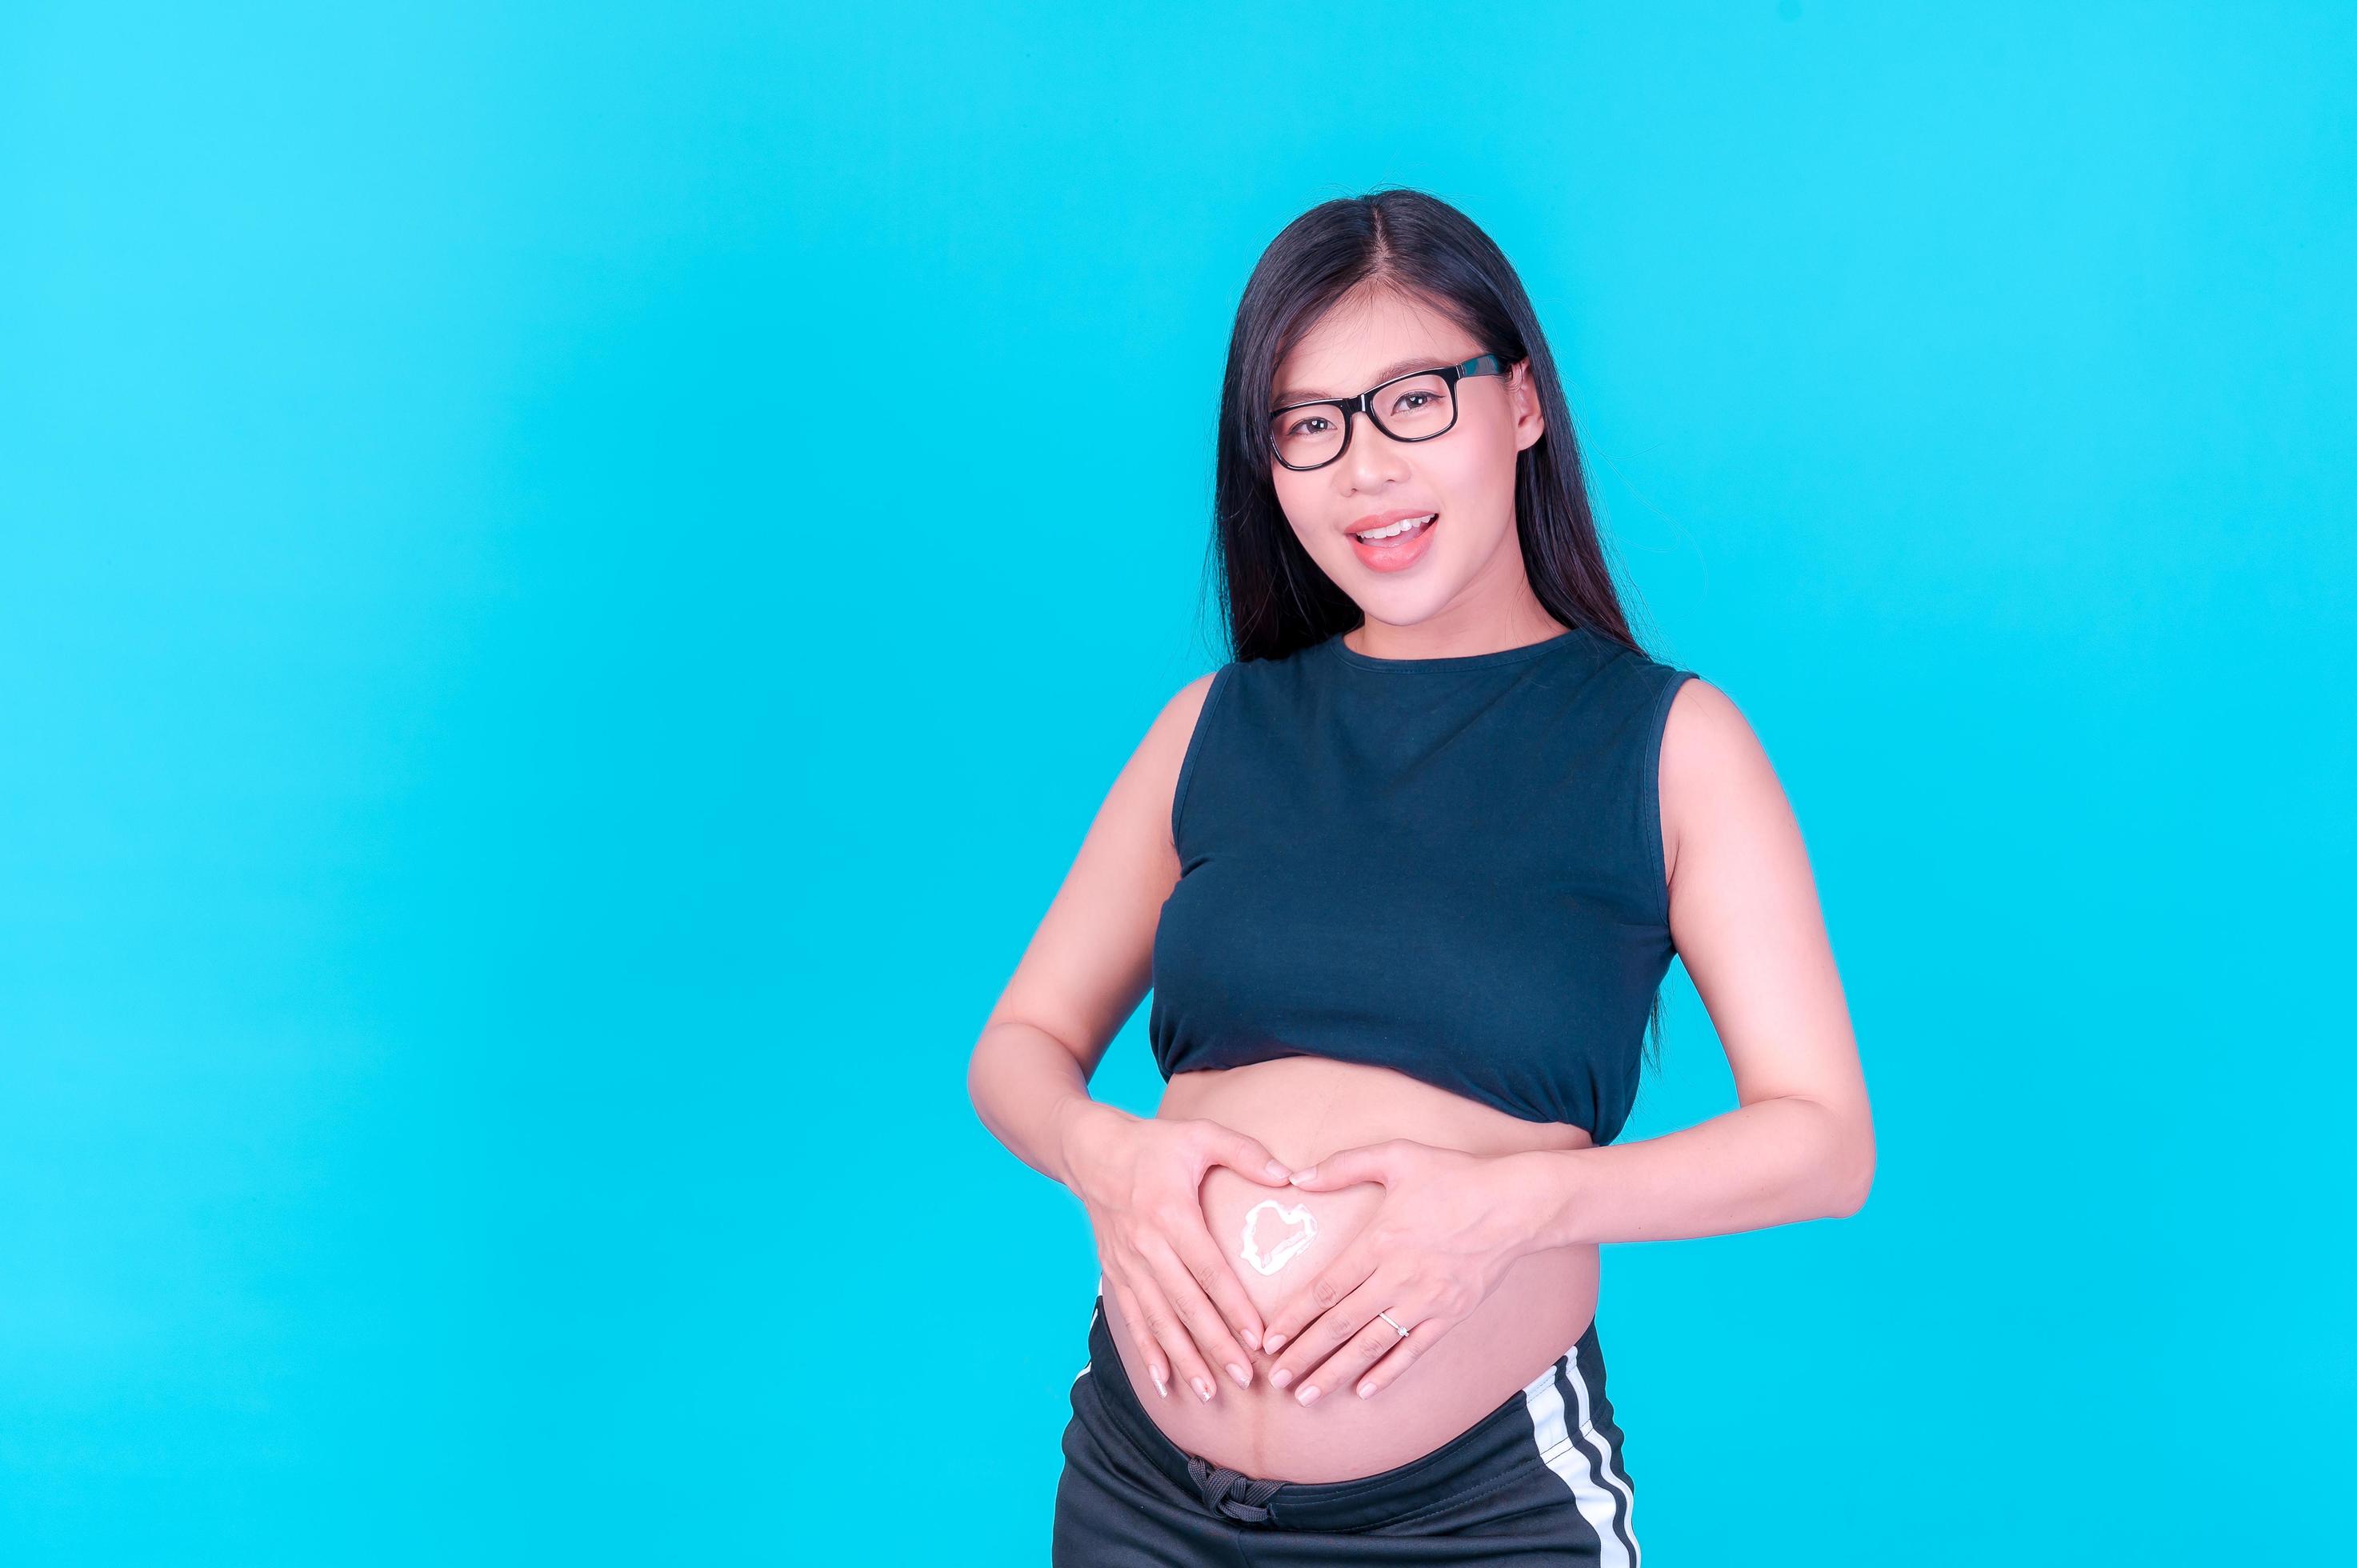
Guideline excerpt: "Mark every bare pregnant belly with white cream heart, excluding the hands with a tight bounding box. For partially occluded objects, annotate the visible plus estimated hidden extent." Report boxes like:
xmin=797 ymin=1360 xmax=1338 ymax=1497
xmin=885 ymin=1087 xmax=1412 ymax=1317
xmin=1106 ymin=1056 xmax=1595 ymax=1481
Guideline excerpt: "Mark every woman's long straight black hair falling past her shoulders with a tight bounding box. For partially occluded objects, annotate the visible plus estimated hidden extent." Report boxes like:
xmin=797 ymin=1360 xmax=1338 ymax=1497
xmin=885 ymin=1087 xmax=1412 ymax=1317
xmin=1211 ymin=186 xmax=1662 ymax=1068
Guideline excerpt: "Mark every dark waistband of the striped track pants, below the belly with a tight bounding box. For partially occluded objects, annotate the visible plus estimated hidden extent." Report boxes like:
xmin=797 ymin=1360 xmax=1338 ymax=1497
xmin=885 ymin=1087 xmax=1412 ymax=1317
xmin=1089 ymin=1297 xmax=1600 ymax=1530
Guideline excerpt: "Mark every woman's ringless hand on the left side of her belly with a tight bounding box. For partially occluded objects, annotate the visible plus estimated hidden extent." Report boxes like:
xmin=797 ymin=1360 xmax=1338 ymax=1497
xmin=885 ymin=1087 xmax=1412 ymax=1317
xmin=1063 ymin=1101 xmax=1291 ymax=1401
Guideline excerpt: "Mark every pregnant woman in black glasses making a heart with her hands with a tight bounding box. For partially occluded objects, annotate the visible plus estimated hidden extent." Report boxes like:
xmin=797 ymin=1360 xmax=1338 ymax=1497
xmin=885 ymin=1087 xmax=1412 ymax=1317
xmin=969 ymin=191 xmax=1874 ymax=1568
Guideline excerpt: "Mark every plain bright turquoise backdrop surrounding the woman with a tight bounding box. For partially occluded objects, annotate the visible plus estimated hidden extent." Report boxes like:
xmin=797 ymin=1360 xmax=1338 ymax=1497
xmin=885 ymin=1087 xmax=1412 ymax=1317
xmin=0 ymin=0 xmax=2357 ymax=1568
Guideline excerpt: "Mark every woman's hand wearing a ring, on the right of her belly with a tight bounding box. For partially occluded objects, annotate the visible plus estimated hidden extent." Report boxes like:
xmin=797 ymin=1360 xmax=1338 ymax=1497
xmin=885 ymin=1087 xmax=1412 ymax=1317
xmin=1261 ymin=1139 xmax=1539 ymax=1406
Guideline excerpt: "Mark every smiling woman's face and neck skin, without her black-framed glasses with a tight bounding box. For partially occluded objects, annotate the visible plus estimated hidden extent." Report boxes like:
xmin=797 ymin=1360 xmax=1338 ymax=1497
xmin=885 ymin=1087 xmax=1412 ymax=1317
xmin=1268 ymin=288 xmax=1544 ymax=627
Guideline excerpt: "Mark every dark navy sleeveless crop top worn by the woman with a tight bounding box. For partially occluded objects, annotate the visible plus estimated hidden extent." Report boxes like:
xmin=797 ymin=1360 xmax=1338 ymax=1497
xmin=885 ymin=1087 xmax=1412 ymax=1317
xmin=1148 ymin=627 xmax=1690 ymax=1143
